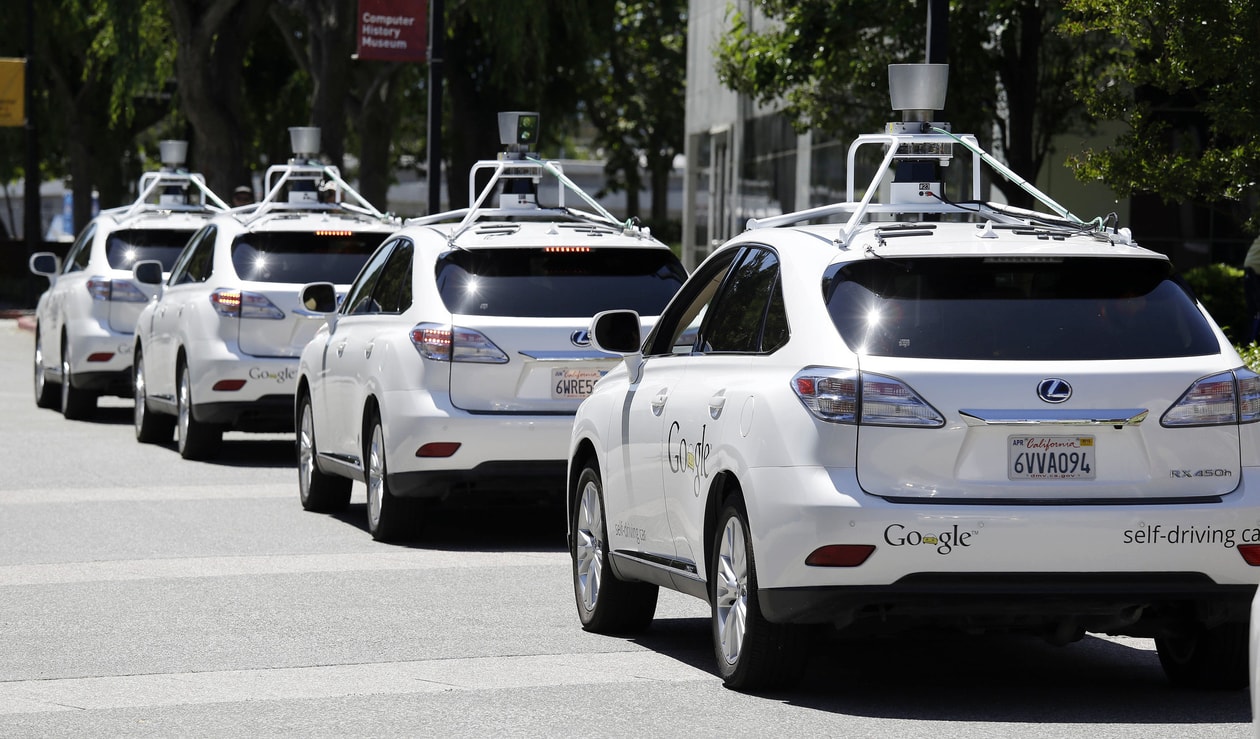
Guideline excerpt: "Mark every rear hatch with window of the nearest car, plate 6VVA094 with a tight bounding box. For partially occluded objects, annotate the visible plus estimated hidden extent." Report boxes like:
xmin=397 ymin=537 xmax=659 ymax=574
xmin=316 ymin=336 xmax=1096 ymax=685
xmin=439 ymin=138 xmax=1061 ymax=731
xmin=828 ymin=257 xmax=1255 ymax=502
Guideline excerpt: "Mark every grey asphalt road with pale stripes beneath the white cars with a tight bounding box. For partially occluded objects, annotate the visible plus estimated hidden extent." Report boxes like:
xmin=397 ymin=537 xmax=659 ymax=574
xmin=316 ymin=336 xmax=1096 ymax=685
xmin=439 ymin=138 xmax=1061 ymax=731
xmin=0 ymin=320 xmax=1251 ymax=739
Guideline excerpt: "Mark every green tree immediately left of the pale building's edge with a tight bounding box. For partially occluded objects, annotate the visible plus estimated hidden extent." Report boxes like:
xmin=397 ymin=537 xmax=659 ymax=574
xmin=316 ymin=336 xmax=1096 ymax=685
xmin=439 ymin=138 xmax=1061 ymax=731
xmin=583 ymin=0 xmax=687 ymax=230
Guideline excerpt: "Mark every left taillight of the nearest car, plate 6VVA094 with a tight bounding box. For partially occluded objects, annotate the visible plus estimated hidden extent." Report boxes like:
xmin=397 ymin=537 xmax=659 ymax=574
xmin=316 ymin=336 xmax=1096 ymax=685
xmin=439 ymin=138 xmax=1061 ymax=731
xmin=791 ymin=368 xmax=945 ymax=428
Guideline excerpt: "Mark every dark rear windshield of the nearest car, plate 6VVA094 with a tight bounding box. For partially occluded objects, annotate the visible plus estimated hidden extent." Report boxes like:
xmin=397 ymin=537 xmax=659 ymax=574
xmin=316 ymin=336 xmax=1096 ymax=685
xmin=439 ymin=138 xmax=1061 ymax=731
xmin=823 ymin=257 xmax=1220 ymax=360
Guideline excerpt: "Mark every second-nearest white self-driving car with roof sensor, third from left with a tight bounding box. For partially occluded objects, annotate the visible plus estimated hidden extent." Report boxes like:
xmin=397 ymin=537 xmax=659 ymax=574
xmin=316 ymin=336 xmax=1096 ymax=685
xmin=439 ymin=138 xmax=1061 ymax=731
xmin=296 ymin=113 xmax=685 ymax=540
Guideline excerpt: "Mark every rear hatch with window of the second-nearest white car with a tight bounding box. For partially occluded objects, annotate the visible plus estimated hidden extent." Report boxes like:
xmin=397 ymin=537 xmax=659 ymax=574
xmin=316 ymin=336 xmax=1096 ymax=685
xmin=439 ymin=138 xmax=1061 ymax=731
xmin=437 ymin=247 xmax=685 ymax=413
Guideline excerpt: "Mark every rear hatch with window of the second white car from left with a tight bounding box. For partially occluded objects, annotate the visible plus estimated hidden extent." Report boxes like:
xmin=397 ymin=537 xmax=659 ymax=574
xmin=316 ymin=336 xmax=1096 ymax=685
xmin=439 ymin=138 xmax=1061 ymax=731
xmin=232 ymin=229 xmax=387 ymax=356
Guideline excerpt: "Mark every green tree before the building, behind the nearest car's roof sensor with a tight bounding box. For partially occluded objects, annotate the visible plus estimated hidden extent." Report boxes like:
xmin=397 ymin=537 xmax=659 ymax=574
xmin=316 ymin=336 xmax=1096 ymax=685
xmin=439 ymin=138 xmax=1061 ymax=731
xmin=717 ymin=0 xmax=1092 ymax=206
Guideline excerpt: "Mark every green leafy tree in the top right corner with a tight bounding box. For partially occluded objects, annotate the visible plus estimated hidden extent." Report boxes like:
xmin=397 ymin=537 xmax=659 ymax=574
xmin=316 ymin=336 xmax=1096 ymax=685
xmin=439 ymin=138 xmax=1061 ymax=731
xmin=1065 ymin=0 xmax=1260 ymax=230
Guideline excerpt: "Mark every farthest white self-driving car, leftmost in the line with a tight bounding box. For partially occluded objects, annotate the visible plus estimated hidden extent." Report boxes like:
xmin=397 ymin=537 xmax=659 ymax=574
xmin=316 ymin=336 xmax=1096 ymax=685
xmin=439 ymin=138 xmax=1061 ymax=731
xmin=30 ymin=141 xmax=228 ymax=418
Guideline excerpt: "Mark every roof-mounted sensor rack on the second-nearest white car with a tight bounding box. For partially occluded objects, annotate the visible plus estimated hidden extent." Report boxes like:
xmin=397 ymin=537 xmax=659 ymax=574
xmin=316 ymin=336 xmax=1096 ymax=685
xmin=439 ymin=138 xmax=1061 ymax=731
xmin=407 ymin=112 xmax=651 ymax=244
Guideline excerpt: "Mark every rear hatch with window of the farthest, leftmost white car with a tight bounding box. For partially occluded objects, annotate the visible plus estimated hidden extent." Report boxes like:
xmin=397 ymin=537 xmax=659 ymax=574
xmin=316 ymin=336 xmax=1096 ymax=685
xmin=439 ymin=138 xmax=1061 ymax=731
xmin=105 ymin=223 xmax=200 ymax=334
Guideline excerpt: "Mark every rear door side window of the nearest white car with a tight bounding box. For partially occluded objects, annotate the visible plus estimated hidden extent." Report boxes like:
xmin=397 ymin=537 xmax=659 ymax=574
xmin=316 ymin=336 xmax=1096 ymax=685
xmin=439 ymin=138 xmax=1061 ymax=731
xmin=701 ymin=248 xmax=788 ymax=354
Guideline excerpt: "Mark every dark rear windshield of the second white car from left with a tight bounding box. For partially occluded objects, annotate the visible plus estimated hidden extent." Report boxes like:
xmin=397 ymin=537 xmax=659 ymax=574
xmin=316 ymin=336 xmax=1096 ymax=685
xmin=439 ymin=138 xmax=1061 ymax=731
xmin=232 ymin=230 xmax=384 ymax=285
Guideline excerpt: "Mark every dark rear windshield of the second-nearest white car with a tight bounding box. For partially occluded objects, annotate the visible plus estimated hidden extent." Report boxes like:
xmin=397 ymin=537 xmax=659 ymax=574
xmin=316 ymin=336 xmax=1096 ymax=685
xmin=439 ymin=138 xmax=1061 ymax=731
xmin=437 ymin=248 xmax=687 ymax=317
